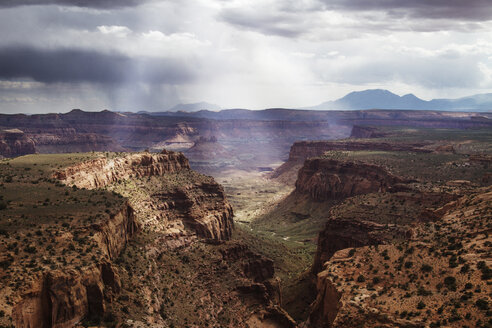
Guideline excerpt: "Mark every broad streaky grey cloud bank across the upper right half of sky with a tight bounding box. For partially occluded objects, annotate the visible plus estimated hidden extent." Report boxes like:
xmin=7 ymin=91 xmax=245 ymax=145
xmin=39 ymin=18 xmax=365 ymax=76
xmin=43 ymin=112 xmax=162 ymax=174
xmin=219 ymin=0 xmax=492 ymax=39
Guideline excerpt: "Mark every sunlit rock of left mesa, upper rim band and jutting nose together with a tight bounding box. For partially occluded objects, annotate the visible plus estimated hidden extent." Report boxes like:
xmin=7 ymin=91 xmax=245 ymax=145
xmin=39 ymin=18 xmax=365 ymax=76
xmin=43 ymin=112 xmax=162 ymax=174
xmin=54 ymin=150 xmax=234 ymax=241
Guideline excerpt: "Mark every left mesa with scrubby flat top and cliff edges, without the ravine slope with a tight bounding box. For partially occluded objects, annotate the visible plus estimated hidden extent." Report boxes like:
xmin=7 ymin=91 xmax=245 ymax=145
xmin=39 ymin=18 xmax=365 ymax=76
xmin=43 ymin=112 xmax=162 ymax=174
xmin=0 ymin=151 xmax=236 ymax=328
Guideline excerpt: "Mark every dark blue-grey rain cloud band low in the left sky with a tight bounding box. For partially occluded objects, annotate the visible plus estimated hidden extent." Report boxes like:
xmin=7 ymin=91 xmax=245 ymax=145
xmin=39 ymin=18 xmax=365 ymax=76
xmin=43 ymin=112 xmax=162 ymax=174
xmin=0 ymin=47 xmax=193 ymax=84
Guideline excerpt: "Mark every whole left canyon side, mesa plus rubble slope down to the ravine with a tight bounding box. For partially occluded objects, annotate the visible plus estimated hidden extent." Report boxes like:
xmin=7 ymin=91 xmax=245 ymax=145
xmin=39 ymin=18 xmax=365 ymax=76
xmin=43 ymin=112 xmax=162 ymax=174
xmin=0 ymin=151 xmax=294 ymax=327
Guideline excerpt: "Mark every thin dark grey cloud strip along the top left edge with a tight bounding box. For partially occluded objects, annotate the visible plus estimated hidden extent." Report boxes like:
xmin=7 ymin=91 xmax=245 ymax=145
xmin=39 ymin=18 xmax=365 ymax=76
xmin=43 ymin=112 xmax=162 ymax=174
xmin=0 ymin=0 xmax=151 ymax=9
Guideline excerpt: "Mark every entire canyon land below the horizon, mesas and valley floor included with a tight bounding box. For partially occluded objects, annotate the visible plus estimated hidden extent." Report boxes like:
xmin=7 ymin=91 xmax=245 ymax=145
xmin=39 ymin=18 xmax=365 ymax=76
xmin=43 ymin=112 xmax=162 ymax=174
xmin=0 ymin=111 xmax=492 ymax=328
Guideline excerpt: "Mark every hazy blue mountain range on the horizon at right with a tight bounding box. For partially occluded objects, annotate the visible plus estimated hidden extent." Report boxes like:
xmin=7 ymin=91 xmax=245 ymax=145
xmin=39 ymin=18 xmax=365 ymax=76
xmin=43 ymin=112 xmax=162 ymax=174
xmin=304 ymin=89 xmax=492 ymax=111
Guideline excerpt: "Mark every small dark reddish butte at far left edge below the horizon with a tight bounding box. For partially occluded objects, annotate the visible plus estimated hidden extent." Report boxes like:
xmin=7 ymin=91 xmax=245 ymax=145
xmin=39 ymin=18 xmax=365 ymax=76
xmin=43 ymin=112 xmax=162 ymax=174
xmin=0 ymin=129 xmax=36 ymax=157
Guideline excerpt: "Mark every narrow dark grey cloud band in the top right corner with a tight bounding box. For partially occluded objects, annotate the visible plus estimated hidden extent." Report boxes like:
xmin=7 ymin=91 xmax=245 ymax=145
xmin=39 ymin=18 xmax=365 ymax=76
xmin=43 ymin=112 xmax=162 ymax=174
xmin=319 ymin=0 xmax=492 ymax=21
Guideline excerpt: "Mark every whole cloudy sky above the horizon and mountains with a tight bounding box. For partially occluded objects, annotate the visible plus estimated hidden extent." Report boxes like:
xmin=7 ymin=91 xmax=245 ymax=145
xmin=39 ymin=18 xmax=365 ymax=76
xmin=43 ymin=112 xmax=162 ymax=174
xmin=0 ymin=0 xmax=492 ymax=113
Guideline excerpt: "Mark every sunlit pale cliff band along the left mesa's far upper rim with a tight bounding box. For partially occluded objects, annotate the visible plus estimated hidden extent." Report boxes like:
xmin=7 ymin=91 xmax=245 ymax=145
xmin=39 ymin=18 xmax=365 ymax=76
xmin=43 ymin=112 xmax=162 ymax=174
xmin=54 ymin=150 xmax=190 ymax=189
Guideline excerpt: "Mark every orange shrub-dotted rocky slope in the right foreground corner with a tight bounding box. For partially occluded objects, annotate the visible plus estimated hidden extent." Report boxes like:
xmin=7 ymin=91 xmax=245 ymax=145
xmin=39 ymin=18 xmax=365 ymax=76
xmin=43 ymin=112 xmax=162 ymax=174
xmin=309 ymin=187 xmax=492 ymax=327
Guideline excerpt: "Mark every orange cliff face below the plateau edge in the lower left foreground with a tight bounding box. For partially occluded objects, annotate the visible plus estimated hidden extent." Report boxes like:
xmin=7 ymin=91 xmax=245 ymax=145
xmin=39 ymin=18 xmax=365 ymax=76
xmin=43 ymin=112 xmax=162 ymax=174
xmin=12 ymin=203 xmax=138 ymax=328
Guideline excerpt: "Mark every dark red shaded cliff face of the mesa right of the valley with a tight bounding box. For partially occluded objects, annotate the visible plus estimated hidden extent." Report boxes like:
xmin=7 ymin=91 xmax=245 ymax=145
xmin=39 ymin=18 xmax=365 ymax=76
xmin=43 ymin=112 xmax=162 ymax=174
xmin=296 ymin=158 xmax=403 ymax=201
